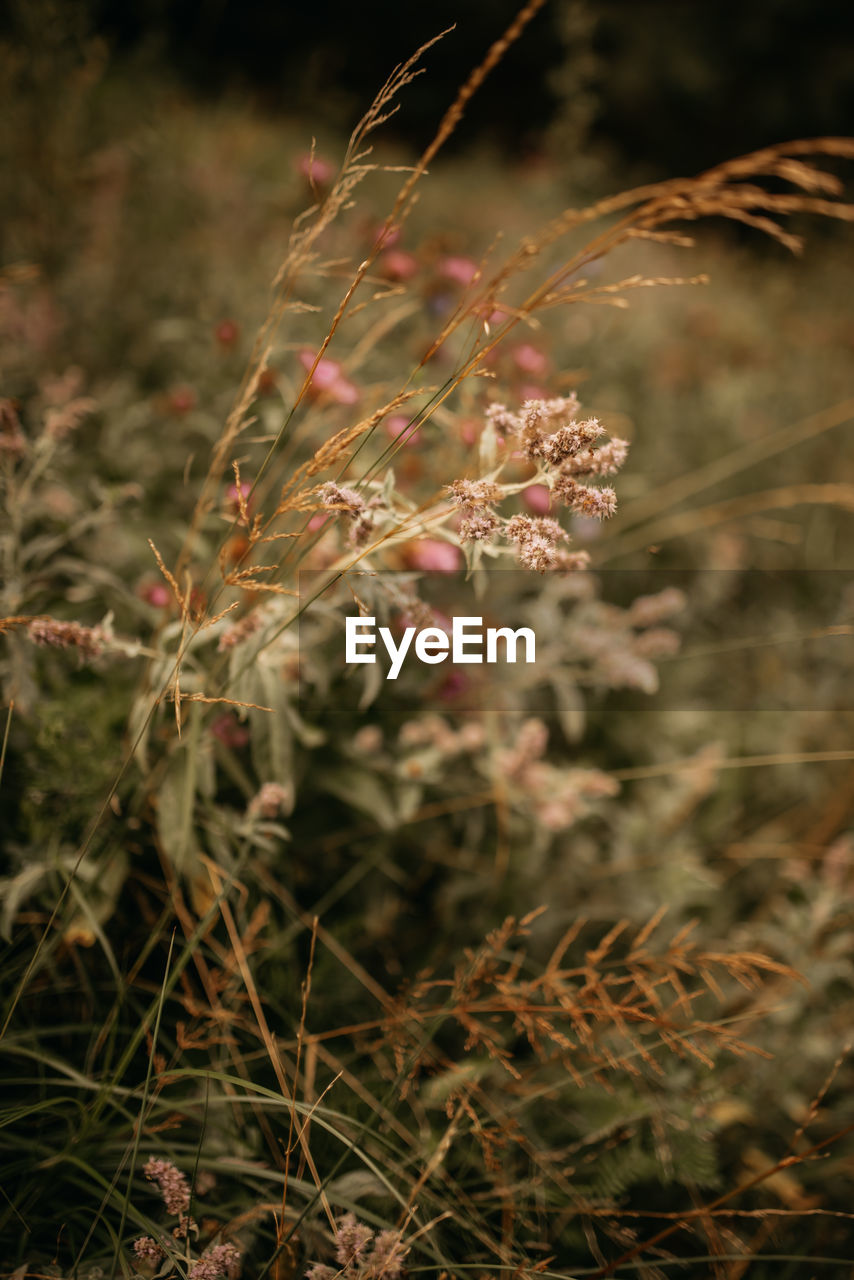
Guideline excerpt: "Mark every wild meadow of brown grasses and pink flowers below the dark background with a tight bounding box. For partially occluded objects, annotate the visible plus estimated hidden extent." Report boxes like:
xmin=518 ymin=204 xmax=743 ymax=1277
xmin=0 ymin=12 xmax=854 ymax=1280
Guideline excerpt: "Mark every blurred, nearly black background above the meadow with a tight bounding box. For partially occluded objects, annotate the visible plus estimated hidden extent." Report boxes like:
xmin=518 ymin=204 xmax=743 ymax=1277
xmin=0 ymin=0 xmax=854 ymax=175
